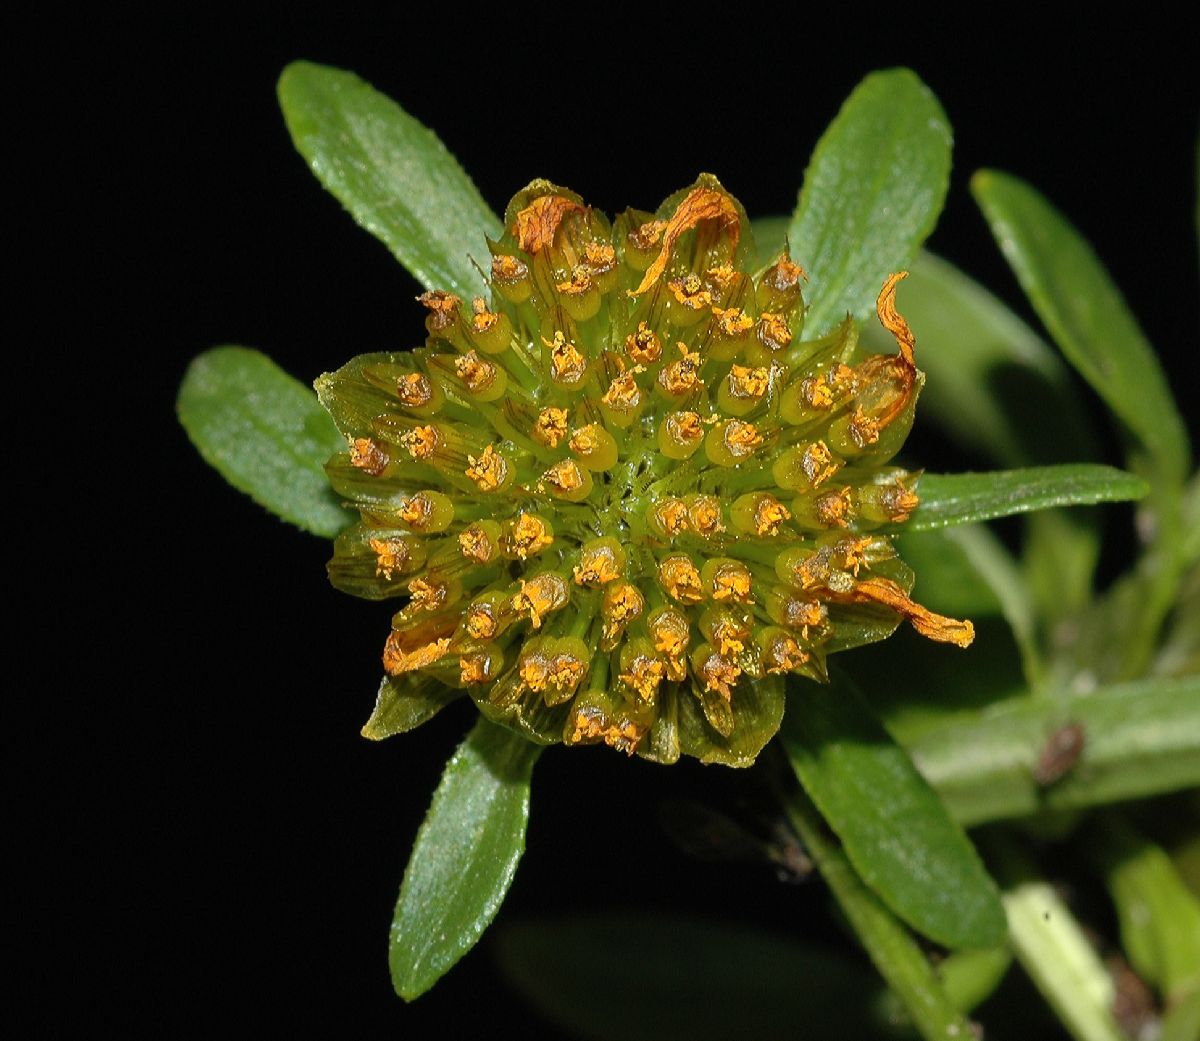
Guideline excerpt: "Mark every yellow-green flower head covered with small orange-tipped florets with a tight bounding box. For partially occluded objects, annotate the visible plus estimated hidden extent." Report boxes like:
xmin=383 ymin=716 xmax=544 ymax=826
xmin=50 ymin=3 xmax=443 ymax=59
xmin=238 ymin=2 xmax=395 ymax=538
xmin=317 ymin=176 xmax=972 ymax=765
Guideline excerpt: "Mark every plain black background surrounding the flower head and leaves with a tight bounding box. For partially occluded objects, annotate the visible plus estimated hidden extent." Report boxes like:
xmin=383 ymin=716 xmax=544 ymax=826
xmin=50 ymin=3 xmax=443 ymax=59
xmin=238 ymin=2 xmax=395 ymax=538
xmin=32 ymin=12 xmax=1198 ymax=1037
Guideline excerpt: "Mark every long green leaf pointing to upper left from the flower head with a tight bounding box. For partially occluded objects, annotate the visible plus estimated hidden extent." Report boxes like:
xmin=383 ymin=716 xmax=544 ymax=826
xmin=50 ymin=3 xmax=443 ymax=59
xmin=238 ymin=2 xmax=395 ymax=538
xmin=278 ymin=61 xmax=502 ymax=300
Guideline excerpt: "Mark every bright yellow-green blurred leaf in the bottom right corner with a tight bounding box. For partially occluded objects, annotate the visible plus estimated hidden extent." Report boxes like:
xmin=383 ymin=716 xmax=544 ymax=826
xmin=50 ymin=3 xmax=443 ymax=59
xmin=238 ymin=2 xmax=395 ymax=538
xmin=1088 ymin=814 xmax=1200 ymax=1004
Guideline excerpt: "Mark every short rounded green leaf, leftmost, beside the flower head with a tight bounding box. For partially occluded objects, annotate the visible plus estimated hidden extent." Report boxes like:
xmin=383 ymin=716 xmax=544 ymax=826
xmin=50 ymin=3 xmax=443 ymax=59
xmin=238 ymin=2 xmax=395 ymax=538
xmin=175 ymin=347 xmax=354 ymax=538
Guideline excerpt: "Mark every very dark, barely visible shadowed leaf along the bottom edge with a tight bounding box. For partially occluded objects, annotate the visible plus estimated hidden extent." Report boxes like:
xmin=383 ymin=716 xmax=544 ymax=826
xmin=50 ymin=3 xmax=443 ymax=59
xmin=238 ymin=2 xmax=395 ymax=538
xmin=493 ymin=910 xmax=877 ymax=1041
